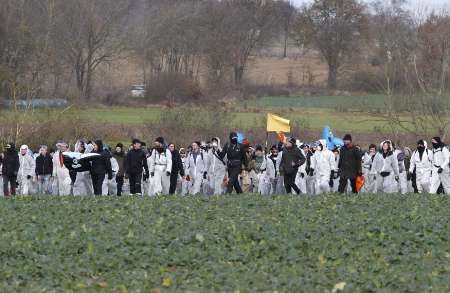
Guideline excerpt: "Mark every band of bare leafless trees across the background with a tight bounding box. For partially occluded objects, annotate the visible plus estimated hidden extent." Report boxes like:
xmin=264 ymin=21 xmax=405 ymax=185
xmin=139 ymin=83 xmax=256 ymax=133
xmin=0 ymin=0 xmax=450 ymax=101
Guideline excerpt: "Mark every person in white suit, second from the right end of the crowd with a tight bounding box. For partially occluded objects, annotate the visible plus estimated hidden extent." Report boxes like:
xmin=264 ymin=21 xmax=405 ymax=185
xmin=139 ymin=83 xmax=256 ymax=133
xmin=409 ymin=140 xmax=433 ymax=193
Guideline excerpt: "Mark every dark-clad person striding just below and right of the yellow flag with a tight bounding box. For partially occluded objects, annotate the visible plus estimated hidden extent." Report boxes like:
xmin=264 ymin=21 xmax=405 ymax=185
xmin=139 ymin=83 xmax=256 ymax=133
xmin=280 ymin=137 xmax=306 ymax=194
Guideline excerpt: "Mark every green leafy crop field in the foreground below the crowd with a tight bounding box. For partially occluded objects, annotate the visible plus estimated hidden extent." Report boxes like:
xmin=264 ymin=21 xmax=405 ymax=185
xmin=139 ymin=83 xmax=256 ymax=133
xmin=0 ymin=194 xmax=450 ymax=292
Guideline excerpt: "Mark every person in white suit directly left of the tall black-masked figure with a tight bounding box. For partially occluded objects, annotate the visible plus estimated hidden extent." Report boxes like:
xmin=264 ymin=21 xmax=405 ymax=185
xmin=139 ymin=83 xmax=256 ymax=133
xmin=208 ymin=137 xmax=227 ymax=195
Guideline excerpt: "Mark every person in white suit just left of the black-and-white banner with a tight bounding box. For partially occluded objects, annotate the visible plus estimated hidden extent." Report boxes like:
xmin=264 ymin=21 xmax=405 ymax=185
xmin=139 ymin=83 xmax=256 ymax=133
xmin=53 ymin=142 xmax=72 ymax=196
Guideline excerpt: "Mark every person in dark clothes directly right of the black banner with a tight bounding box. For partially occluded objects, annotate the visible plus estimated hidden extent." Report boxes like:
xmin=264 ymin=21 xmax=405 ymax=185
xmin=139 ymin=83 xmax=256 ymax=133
xmin=91 ymin=140 xmax=113 ymax=195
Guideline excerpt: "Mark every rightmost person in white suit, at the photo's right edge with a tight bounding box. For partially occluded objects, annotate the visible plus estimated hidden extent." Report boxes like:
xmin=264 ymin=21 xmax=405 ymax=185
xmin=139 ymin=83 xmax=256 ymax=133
xmin=430 ymin=137 xmax=450 ymax=194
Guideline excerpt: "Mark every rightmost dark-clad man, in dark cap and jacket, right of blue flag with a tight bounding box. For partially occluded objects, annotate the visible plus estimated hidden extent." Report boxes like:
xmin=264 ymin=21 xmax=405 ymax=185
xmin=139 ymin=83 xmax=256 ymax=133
xmin=338 ymin=134 xmax=362 ymax=193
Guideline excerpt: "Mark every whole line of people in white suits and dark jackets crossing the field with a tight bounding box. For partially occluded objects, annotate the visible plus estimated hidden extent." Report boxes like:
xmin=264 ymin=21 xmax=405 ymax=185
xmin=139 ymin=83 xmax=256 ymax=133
xmin=0 ymin=132 xmax=450 ymax=196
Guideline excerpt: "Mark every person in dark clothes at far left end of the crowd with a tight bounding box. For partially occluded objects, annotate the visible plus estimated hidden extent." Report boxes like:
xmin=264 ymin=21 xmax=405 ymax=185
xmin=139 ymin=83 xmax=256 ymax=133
xmin=2 ymin=143 xmax=20 ymax=196
